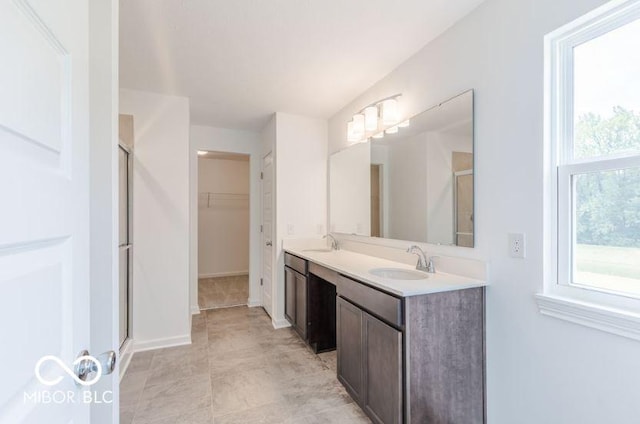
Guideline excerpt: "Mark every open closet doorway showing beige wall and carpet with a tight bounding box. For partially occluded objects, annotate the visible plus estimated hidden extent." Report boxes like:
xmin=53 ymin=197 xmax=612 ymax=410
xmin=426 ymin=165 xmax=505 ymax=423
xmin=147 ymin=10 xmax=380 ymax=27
xmin=198 ymin=151 xmax=250 ymax=310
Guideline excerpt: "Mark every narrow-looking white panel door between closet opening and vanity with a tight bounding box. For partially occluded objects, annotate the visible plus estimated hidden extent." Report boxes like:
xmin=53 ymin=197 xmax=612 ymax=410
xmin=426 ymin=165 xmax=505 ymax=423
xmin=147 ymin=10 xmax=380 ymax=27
xmin=262 ymin=153 xmax=273 ymax=316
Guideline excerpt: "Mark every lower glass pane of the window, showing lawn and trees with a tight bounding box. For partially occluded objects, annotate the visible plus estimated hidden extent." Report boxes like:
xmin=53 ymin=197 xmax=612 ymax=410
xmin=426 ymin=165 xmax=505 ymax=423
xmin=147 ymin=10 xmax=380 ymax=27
xmin=573 ymin=168 xmax=640 ymax=295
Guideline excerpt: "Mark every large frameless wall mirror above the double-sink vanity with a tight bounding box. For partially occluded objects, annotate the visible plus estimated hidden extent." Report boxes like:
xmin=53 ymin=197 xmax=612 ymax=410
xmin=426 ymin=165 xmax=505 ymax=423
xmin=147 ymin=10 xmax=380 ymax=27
xmin=329 ymin=91 xmax=474 ymax=247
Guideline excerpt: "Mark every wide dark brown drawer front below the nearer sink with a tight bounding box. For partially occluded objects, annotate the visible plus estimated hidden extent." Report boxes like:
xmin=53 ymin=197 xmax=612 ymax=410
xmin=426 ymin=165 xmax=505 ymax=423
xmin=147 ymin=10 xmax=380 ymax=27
xmin=337 ymin=275 xmax=403 ymax=327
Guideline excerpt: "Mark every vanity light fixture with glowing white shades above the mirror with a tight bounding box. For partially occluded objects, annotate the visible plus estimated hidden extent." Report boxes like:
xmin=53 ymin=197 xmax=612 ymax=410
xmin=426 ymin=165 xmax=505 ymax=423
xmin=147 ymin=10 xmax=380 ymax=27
xmin=347 ymin=94 xmax=409 ymax=143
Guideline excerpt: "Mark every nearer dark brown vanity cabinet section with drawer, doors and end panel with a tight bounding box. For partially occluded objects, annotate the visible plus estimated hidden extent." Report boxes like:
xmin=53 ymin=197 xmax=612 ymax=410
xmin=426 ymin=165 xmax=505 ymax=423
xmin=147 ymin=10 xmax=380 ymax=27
xmin=336 ymin=276 xmax=485 ymax=424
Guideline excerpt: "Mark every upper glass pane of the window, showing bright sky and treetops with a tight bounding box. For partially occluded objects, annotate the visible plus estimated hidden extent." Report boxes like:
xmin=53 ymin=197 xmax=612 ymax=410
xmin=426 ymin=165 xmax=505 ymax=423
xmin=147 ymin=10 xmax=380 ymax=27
xmin=573 ymin=19 xmax=640 ymax=159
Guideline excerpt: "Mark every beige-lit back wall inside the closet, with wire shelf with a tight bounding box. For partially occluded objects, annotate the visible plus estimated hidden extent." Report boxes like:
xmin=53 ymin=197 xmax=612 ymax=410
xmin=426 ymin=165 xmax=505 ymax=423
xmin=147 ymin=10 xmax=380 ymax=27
xmin=198 ymin=157 xmax=249 ymax=278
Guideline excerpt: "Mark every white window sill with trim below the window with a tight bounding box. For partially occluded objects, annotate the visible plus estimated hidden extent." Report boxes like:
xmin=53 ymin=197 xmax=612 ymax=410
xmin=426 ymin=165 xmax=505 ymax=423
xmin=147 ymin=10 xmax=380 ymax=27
xmin=535 ymin=294 xmax=640 ymax=340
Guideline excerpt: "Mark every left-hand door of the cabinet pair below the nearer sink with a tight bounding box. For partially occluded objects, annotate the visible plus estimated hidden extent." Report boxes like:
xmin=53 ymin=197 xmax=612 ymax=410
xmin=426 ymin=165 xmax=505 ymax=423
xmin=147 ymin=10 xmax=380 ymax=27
xmin=336 ymin=297 xmax=363 ymax=404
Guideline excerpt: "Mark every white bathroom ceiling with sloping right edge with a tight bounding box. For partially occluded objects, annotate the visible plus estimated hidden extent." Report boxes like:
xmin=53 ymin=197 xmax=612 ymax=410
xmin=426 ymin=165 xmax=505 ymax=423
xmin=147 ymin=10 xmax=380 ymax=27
xmin=120 ymin=0 xmax=482 ymax=130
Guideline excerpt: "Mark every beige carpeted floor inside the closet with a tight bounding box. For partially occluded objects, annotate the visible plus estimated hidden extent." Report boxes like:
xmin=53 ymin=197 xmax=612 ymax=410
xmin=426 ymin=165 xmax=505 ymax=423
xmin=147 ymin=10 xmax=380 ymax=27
xmin=198 ymin=275 xmax=249 ymax=310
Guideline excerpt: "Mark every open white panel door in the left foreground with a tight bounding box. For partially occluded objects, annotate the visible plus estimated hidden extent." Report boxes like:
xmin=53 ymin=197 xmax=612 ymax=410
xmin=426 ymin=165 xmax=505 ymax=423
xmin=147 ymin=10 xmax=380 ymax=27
xmin=0 ymin=0 xmax=90 ymax=423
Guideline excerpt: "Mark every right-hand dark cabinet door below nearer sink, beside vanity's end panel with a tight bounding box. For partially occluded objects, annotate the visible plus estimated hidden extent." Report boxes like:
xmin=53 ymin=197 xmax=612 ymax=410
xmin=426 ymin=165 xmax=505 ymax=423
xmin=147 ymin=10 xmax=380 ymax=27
xmin=362 ymin=312 xmax=402 ymax=424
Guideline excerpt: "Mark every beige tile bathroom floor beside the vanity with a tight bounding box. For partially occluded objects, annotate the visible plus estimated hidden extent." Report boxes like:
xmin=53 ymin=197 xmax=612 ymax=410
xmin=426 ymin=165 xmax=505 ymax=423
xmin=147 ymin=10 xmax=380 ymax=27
xmin=120 ymin=307 xmax=370 ymax=424
